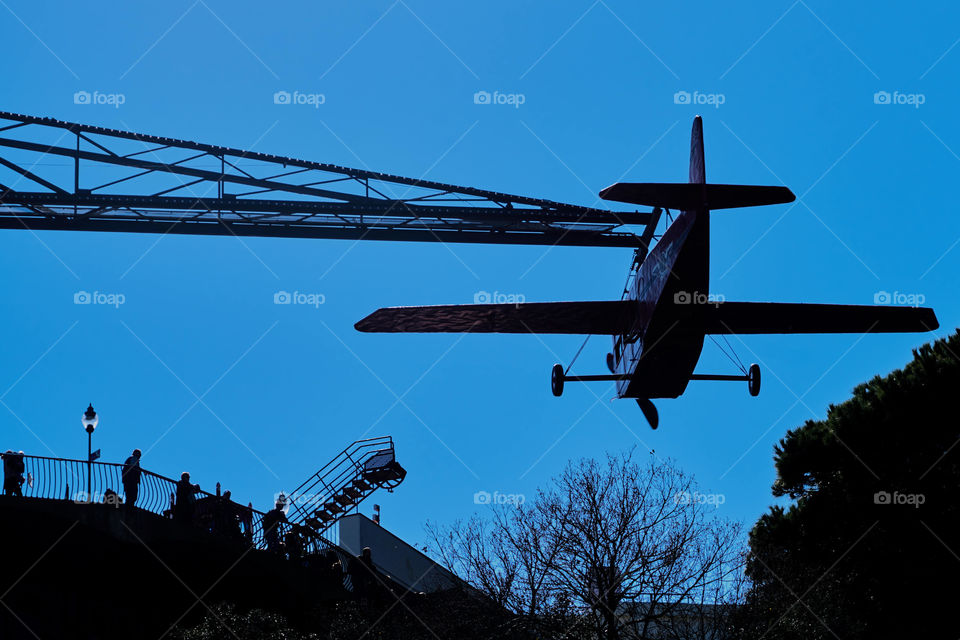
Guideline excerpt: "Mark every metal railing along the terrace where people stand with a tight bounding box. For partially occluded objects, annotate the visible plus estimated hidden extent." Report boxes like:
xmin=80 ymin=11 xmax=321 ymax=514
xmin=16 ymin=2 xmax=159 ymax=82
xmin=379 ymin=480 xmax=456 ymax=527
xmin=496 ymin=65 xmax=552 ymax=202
xmin=11 ymin=455 xmax=349 ymax=566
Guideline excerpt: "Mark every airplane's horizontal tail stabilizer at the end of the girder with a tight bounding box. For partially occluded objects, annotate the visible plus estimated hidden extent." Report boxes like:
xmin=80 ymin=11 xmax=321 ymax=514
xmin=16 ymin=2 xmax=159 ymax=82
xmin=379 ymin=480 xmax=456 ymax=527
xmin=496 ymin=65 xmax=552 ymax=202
xmin=600 ymin=182 xmax=796 ymax=211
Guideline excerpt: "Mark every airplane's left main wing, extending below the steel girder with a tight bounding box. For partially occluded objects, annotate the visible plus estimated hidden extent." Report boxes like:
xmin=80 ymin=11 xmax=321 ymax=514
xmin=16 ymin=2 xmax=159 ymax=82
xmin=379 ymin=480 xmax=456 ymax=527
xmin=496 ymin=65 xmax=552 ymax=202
xmin=354 ymin=300 xmax=636 ymax=335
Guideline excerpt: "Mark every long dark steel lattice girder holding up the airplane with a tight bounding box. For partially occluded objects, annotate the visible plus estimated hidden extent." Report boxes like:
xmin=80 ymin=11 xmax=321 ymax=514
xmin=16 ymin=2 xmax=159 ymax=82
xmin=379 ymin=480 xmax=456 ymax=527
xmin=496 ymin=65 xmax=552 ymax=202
xmin=0 ymin=112 xmax=658 ymax=251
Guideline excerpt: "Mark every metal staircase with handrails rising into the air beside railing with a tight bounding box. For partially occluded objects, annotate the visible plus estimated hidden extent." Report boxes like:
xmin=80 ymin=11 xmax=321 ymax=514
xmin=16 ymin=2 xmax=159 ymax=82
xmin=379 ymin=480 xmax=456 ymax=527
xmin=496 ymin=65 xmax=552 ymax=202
xmin=287 ymin=436 xmax=407 ymax=534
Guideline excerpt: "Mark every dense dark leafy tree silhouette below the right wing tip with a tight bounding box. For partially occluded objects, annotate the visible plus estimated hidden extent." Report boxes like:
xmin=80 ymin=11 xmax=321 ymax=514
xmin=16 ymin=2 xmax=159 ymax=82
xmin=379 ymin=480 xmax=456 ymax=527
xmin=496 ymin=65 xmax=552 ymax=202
xmin=742 ymin=332 xmax=960 ymax=638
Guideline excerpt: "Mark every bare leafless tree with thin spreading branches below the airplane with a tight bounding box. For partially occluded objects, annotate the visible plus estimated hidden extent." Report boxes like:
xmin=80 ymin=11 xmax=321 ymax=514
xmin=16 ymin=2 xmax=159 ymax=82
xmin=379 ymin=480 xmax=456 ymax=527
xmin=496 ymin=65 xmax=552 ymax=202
xmin=428 ymin=452 xmax=744 ymax=640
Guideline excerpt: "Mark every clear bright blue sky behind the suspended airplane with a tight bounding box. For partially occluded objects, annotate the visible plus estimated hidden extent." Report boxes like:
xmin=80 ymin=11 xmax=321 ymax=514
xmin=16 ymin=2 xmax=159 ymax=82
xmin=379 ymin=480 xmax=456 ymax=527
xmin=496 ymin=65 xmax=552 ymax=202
xmin=0 ymin=0 xmax=960 ymax=541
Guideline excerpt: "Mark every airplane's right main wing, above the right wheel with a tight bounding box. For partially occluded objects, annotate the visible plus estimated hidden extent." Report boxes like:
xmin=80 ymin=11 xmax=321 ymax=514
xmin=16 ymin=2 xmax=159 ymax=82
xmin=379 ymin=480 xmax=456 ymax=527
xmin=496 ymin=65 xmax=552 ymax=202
xmin=703 ymin=302 xmax=940 ymax=335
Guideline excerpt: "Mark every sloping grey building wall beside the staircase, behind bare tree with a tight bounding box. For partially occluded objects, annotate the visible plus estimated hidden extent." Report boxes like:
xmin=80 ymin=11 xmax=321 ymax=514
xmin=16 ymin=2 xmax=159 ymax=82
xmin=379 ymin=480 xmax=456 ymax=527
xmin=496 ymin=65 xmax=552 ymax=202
xmin=339 ymin=513 xmax=459 ymax=592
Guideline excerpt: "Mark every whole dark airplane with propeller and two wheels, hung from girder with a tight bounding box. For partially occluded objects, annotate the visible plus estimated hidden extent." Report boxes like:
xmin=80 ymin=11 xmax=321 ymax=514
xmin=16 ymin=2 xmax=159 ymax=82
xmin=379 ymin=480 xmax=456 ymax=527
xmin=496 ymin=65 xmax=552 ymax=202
xmin=355 ymin=116 xmax=939 ymax=429
